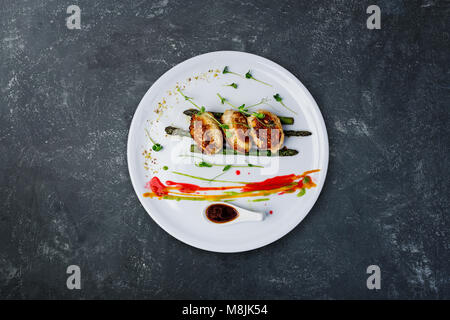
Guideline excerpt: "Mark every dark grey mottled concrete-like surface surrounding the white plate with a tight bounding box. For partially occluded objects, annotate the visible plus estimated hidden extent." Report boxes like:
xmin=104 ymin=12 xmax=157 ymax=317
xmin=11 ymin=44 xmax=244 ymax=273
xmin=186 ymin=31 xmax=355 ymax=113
xmin=0 ymin=0 xmax=450 ymax=299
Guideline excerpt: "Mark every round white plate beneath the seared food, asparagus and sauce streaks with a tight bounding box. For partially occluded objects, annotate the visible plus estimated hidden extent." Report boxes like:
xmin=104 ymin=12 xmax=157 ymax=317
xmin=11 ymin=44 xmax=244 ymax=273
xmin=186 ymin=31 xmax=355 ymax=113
xmin=127 ymin=51 xmax=328 ymax=252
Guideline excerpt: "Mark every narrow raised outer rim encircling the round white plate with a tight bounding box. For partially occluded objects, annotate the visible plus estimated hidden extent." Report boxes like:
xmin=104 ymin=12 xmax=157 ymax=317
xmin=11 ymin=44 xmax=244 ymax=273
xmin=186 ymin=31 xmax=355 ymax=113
xmin=127 ymin=50 xmax=329 ymax=253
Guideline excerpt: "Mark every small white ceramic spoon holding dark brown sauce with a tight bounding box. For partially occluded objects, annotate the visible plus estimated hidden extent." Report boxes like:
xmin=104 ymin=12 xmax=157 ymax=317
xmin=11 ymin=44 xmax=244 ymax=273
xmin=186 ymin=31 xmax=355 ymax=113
xmin=203 ymin=202 xmax=265 ymax=226
